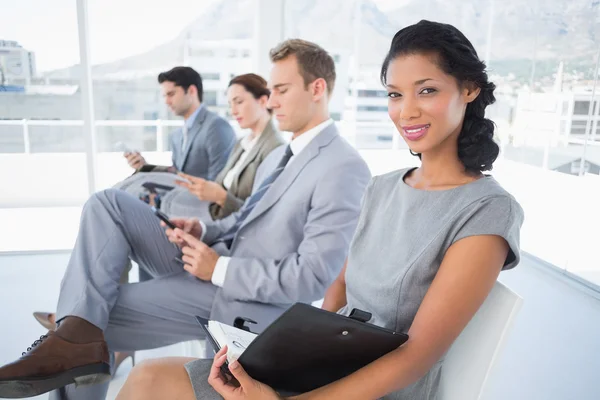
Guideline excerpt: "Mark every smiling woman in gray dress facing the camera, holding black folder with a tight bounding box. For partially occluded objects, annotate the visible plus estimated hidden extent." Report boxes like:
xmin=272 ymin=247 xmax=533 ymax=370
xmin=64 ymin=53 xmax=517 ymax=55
xmin=118 ymin=21 xmax=523 ymax=400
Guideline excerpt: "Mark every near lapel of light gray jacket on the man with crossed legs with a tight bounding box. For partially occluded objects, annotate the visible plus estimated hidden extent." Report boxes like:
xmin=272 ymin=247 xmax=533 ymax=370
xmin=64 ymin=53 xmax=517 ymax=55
xmin=242 ymin=123 xmax=338 ymax=227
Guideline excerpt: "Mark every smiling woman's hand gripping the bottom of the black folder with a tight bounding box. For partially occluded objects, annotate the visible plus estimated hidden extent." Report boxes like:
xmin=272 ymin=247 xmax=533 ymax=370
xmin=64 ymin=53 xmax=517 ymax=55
xmin=208 ymin=346 xmax=283 ymax=400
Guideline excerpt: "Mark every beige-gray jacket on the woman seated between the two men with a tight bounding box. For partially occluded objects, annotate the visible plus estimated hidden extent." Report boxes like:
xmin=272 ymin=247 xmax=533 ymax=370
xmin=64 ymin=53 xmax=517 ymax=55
xmin=209 ymin=121 xmax=285 ymax=219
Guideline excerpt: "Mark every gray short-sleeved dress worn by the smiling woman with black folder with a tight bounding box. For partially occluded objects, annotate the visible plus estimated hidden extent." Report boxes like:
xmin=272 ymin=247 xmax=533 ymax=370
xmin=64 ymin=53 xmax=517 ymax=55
xmin=186 ymin=169 xmax=523 ymax=400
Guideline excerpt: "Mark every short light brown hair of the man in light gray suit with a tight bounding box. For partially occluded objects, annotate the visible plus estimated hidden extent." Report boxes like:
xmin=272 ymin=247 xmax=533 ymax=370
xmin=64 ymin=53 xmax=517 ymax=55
xmin=269 ymin=39 xmax=335 ymax=95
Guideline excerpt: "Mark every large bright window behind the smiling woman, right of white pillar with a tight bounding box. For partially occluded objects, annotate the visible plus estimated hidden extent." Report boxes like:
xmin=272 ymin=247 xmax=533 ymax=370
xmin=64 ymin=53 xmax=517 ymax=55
xmin=285 ymin=0 xmax=600 ymax=284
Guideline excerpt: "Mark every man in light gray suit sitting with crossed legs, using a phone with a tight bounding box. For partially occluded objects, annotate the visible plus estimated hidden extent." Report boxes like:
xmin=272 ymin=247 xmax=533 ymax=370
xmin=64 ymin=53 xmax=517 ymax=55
xmin=0 ymin=40 xmax=370 ymax=400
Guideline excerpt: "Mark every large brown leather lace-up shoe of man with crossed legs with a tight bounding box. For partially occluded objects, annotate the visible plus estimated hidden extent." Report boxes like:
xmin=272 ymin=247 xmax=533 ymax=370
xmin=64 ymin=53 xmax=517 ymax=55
xmin=0 ymin=332 xmax=110 ymax=399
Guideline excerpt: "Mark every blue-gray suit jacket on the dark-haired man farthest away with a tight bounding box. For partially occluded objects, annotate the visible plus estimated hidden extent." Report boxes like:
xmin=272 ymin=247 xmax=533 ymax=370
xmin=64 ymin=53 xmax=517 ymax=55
xmin=170 ymin=106 xmax=236 ymax=181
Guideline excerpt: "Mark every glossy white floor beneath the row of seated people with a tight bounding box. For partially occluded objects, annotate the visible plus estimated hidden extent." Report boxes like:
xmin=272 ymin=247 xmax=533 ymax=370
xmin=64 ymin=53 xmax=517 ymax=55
xmin=0 ymin=252 xmax=600 ymax=400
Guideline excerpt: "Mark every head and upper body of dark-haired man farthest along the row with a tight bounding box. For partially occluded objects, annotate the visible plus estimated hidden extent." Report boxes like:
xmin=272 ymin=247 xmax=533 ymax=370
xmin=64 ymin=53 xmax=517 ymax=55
xmin=125 ymin=67 xmax=235 ymax=180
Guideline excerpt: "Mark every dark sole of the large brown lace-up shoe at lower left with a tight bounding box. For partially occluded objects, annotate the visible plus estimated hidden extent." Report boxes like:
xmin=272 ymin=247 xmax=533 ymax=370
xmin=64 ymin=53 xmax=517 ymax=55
xmin=0 ymin=363 xmax=111 ymax=399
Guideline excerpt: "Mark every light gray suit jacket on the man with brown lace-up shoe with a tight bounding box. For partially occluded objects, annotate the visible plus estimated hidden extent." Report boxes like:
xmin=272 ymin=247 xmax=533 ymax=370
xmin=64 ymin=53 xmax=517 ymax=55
xmin=203 ymin=125 xmax=371 ymax=332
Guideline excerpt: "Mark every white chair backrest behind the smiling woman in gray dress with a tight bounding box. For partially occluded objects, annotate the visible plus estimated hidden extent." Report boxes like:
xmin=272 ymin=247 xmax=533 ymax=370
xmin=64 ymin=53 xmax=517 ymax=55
xmin=439 ymin=282 xmax=523 ymax=400
